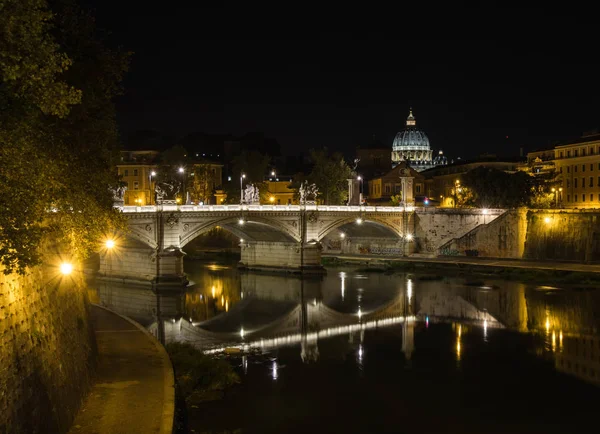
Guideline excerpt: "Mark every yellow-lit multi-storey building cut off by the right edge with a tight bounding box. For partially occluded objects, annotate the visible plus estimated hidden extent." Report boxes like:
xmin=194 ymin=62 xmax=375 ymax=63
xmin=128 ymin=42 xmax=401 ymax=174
xmin=554 ymin=131 xmax=600 ymax=208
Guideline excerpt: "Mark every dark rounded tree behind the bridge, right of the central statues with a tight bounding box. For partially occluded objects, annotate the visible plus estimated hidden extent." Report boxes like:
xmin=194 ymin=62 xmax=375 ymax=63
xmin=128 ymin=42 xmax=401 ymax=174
xmin=308 ymin=149 xmax=352 ymax=205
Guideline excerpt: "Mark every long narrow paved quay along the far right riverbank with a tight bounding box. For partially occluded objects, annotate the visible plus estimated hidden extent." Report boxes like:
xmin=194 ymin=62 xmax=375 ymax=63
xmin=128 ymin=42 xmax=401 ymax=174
xmin=323 ymin=255 xmax=600 ymax=273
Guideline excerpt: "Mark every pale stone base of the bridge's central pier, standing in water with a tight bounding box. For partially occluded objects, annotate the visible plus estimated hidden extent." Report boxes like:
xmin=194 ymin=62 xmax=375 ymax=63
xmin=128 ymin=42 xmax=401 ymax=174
xmin=239 ymin=241 xmax=325 ymax=273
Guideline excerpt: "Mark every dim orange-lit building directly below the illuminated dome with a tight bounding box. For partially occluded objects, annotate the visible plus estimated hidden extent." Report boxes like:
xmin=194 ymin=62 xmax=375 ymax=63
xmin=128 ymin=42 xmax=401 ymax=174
xmin=367 ymin=162 xmax=427 ymax=205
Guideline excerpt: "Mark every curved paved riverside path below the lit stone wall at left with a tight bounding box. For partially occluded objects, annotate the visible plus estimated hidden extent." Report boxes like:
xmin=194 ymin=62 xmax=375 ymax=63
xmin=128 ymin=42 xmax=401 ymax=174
xmin=69 ymin=306 xmax=174 ymax=434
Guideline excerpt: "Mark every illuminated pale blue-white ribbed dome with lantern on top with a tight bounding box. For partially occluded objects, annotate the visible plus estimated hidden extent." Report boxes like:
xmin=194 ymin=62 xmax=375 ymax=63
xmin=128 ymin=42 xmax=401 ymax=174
xmin=392 ymin=108 xmax=434 ymax=171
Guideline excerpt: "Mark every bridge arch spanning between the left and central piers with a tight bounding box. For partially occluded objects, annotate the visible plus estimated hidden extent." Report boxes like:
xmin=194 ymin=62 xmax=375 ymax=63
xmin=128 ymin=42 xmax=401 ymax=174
xmin=179 ymin=216 xmax=299 ymax=248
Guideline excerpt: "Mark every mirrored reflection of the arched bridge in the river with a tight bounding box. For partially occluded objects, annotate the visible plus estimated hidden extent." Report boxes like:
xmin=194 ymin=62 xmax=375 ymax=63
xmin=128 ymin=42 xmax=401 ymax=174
xmin=92 ymin=272 xmax=502 ymax=359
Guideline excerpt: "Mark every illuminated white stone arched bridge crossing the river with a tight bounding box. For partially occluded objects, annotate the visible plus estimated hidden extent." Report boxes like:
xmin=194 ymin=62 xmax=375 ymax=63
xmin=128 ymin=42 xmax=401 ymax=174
xmin=99 ymin=205 xmax=504 ymax=285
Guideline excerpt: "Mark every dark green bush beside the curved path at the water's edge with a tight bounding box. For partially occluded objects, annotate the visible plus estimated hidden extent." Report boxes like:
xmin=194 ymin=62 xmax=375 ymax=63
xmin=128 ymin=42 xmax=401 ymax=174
xmin=166 ymin=342 xmax=240 ymax=404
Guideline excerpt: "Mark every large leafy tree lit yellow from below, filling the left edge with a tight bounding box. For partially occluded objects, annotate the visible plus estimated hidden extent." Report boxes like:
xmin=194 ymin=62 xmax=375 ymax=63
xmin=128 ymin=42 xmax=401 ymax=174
xmin=0 ymin=0 xmax=129 ymax=274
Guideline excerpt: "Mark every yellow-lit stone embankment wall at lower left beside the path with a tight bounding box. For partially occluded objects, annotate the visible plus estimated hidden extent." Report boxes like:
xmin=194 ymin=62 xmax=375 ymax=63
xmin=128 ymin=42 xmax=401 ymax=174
xmin=0 ymin=257 xmax=96 ymax=434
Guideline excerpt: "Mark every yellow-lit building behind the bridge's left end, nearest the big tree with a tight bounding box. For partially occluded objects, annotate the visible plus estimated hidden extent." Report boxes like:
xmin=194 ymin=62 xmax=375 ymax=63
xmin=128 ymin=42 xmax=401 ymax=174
xmin=117 ymin=151 xmax=159 ymax=206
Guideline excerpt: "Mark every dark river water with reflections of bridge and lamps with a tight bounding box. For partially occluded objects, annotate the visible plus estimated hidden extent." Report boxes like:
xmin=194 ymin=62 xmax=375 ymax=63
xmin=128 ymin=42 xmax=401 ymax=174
xmin=94 ymin=261 xmax=600 ymax=433
